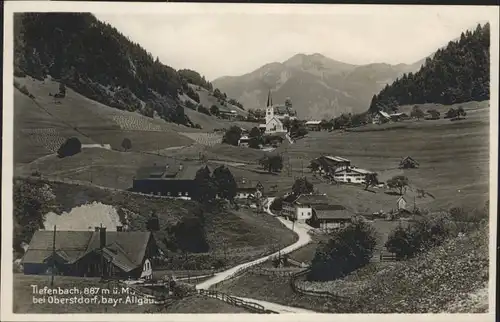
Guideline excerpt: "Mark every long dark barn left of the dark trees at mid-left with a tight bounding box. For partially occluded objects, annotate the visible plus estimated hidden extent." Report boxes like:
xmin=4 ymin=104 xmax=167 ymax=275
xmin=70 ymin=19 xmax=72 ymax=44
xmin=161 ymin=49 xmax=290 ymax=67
xmin=131 ymin=164 xmax=207 ymax=200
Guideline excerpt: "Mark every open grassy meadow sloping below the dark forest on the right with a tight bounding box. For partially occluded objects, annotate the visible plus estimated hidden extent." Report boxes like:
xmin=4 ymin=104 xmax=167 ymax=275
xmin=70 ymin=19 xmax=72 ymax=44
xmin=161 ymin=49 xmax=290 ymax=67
xmin=288 ymin=102 xmax=489 ymax=211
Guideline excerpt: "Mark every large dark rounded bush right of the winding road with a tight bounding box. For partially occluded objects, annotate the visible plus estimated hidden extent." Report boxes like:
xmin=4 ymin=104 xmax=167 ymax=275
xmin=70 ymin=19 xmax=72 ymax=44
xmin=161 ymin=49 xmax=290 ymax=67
xmin=307 ymin=220 xmax=376 ymax=281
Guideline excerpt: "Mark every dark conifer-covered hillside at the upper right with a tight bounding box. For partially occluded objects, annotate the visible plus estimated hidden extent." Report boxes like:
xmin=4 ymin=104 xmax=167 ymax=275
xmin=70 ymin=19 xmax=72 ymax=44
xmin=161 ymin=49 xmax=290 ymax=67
xmin=370 ymin=23 xmax=490 ymax=111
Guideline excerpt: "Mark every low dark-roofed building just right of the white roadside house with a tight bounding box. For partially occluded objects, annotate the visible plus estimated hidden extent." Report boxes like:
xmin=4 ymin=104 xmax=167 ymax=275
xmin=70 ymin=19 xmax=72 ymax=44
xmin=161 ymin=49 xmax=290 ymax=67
xmin=307 ymin=205 xmax=354 ymax=230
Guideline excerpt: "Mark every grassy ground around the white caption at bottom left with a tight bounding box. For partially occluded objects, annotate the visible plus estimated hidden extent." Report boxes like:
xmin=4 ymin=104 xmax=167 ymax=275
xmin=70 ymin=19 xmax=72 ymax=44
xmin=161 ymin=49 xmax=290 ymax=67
xmin=13 ymin=274 xmax=247 ymax=314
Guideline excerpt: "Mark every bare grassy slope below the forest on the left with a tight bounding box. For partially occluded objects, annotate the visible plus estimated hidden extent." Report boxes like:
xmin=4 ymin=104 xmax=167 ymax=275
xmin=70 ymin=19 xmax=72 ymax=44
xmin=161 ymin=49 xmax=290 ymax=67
xmin=14 ymin=77 xmax=195 ymax=163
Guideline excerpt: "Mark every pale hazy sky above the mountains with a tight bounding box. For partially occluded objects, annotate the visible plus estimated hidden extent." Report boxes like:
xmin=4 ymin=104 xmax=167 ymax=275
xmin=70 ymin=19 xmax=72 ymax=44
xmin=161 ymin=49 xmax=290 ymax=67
xmin=95 ymin=5 xmax=495 ymax=80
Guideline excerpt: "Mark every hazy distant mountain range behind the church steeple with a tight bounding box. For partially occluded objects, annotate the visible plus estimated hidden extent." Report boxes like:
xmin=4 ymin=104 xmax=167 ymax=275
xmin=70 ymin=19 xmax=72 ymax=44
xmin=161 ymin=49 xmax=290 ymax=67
xmin=212 ymin=53 xmax=432 ymax=119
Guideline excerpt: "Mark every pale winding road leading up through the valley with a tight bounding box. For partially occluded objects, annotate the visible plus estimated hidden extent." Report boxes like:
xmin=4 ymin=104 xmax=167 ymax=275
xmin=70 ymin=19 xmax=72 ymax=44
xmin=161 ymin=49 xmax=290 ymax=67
xmin=196 ymin=198 xmax=315 ymax=313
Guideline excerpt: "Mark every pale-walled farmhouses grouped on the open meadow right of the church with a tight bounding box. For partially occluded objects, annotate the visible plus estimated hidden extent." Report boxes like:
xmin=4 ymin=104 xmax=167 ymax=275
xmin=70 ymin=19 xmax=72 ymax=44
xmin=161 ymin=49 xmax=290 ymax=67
xmin=309 ymin=155 xmax=375 ymax=184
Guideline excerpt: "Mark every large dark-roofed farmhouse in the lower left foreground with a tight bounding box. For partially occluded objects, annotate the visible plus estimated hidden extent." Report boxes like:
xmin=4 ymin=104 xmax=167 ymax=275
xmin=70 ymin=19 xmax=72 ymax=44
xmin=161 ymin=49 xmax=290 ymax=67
xmin=22 ymin=227 xmax=159 ymax=279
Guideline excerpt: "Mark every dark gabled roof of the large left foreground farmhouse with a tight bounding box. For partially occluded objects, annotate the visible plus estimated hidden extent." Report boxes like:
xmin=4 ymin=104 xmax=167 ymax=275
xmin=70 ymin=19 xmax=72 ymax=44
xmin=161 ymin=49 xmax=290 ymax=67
xmin=23 ymin=230 xmax=151 ymax=272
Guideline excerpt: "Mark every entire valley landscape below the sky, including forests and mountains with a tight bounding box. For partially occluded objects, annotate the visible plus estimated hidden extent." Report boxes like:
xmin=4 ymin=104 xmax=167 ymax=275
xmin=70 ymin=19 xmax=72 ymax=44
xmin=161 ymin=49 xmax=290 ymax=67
xmin=7 ymin=13 xmax=496 ymax=314
